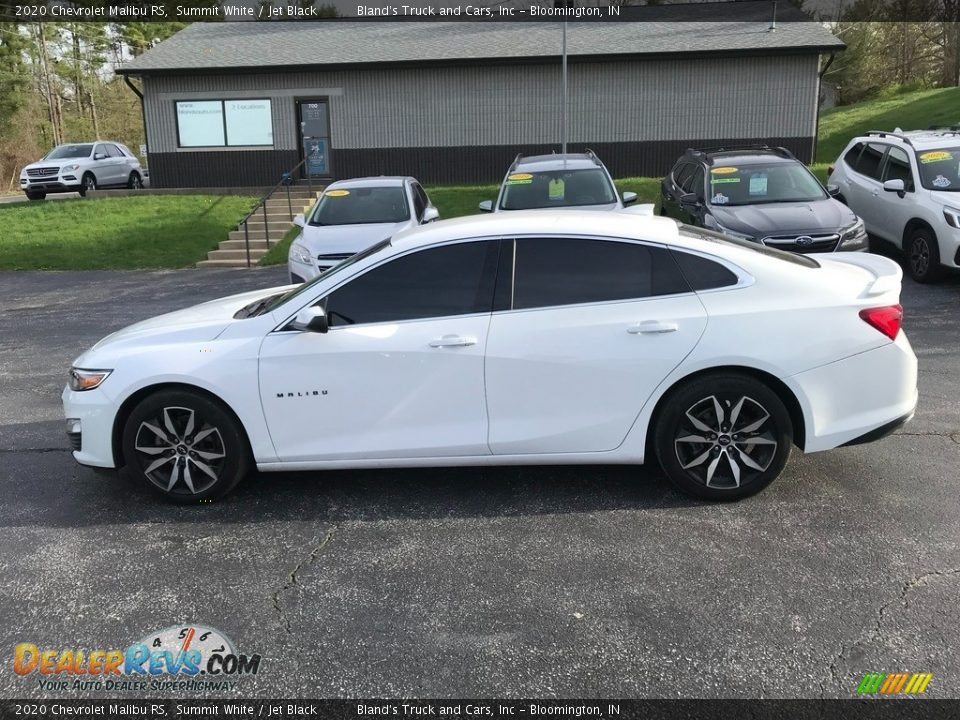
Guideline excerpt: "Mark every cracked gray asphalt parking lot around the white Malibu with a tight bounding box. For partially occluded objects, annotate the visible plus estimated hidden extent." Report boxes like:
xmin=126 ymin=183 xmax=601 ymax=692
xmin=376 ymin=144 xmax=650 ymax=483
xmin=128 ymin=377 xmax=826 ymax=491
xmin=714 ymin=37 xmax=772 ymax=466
xmin=0 ymin=260 xmax=960 ymax=698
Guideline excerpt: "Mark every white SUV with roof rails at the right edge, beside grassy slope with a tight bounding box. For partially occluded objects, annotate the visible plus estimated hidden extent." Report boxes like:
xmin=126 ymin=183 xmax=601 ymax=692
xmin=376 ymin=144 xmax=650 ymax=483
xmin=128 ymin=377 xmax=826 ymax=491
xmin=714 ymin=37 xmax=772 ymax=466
xmin=829 ymin=127 xmax=960 ymax=283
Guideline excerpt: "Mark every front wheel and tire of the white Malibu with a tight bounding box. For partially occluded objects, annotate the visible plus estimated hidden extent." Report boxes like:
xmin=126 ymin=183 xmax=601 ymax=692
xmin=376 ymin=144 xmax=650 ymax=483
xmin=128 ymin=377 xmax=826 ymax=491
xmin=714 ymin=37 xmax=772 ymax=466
xmin=122 ymin=390 xmax=251 ymax=504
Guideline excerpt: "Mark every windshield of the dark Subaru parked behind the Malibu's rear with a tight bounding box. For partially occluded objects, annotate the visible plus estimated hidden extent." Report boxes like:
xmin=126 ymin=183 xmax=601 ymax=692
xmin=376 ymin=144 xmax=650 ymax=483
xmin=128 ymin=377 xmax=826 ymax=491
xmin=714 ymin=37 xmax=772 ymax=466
xmin=710 ymin=162 xmax=828 ymax=206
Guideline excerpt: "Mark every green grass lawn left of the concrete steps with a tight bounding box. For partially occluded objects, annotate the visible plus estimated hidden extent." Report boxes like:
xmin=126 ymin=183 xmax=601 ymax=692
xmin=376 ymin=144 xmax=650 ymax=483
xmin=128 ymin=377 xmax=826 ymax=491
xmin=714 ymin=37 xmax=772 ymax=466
xmin=0 ymin=195 xmax=256 ymax=270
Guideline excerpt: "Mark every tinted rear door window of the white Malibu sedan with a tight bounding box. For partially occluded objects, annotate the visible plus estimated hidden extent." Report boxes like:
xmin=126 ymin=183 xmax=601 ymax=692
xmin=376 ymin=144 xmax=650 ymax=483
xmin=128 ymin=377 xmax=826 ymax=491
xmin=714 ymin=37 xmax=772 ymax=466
xmin=513 ymin=238 xmax=689 ymax=310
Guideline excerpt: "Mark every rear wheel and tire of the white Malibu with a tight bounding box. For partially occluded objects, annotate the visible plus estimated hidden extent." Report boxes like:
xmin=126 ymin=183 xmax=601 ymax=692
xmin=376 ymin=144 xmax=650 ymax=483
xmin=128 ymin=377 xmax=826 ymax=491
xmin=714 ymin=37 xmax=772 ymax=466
xmin=654 ymin=373 xmax=793 ymax=501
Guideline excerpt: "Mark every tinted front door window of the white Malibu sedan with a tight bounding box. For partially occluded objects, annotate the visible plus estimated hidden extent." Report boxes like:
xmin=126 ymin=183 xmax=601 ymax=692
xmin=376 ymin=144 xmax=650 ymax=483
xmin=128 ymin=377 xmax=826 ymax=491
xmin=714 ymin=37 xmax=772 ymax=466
xmin=324 ymin=242 xmax=499 ymax=326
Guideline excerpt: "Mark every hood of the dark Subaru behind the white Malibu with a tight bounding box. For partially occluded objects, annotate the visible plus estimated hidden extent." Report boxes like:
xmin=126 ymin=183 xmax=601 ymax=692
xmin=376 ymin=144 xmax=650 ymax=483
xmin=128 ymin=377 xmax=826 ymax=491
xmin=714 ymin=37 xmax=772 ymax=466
xmin=710 ymin=198 xmax=857 ymax=238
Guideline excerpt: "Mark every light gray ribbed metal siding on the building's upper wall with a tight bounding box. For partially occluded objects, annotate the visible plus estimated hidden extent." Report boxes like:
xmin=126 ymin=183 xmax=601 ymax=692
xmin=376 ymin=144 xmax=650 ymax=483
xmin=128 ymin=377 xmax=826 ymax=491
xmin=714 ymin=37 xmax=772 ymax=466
xmin=144 ymin=54 xmax=817 ymax=153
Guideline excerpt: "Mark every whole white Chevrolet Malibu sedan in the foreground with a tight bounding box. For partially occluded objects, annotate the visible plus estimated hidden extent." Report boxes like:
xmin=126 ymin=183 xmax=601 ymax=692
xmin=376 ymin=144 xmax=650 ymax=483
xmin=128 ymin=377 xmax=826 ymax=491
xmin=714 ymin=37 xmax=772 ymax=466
xmin=63 ymin=211 xmax=917 ymax=502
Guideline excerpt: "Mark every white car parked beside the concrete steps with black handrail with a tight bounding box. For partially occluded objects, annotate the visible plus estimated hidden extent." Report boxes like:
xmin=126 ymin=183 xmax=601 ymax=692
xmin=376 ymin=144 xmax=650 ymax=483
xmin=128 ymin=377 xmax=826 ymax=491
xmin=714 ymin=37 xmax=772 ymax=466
xmin=287 ymin=177 xmax=440 ymax=283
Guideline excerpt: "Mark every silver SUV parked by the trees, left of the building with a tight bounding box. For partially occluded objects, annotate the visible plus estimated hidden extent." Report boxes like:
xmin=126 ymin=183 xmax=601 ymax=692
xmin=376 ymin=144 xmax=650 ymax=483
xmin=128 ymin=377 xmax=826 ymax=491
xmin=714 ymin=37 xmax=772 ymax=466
xmin=20 ymin=140 xmax=144 ymax=200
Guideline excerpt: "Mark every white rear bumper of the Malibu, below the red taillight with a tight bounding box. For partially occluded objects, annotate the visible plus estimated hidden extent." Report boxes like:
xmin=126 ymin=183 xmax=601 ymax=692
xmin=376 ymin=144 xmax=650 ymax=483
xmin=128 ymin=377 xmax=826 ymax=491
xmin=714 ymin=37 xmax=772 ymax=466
xmin=784 ymin=332 xmax=918 ymax=452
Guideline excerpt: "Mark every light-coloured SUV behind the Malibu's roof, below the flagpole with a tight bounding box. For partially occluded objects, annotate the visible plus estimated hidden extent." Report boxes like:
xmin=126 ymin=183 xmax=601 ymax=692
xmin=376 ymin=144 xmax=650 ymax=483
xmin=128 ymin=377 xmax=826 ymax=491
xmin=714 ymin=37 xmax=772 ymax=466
xmin=480 ymin=150 xmax=637 ymax=212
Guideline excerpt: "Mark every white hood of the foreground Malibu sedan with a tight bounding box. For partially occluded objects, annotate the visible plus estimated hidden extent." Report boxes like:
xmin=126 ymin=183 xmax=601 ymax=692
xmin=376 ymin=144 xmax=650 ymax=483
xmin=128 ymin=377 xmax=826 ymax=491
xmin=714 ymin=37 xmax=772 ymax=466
xmin=78 ymin=285 xmax=296 ymax=358
